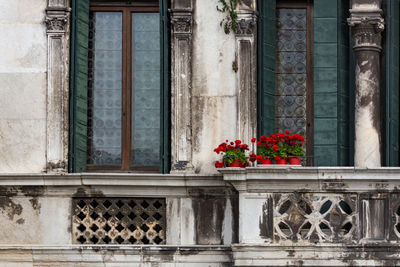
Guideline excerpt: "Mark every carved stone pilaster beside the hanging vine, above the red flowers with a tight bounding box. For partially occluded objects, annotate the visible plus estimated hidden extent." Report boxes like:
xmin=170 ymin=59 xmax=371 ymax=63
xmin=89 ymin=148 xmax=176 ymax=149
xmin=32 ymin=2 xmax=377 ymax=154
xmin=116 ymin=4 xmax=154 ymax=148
xmin=235 ymin=9 xmax=257 ymax=147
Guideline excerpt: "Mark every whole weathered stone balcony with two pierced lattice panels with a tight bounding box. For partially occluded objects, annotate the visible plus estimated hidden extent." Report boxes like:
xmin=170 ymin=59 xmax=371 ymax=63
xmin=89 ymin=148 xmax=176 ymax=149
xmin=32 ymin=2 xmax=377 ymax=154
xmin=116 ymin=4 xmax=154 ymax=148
xmin=0 ymin=169 xmax=400 ymax=267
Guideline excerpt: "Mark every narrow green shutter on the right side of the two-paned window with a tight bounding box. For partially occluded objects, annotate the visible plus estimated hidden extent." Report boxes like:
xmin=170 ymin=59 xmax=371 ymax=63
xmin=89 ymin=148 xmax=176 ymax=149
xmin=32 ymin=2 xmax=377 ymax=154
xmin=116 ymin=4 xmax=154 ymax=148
xmin=159 ymin=0 xmax=170 ymax=173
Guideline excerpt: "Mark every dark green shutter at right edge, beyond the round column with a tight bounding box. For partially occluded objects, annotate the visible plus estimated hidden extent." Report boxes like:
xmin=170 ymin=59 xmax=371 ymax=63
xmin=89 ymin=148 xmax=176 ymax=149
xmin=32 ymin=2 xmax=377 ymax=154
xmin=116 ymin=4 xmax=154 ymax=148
xmin=384 ymin=0 xmax=399 ymax=166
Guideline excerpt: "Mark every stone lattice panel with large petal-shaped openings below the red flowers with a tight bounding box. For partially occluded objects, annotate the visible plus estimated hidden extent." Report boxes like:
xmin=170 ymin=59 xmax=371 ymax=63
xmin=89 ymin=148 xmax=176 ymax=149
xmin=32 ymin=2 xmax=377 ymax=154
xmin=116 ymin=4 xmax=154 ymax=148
xmin=273 ymin=194 xmax=359 ymax=242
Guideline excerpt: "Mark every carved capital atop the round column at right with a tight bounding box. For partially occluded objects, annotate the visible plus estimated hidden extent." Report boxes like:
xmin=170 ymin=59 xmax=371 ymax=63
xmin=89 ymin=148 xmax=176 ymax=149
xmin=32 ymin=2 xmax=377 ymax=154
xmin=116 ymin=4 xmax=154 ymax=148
xmin=347 ymin=9 xmax=385 ymax=52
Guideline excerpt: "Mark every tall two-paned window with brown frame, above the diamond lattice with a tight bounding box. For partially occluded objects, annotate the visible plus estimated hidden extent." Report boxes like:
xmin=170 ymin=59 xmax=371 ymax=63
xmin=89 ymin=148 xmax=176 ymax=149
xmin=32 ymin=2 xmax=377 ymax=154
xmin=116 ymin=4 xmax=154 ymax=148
xmin=87 ymin=1 xmax=160 ymax=171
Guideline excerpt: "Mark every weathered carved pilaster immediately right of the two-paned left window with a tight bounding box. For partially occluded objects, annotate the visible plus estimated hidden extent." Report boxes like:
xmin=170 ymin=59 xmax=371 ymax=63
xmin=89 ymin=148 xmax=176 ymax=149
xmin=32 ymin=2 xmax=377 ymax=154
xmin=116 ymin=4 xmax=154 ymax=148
xmin=170 ymin=4 xmax=193 ymax=172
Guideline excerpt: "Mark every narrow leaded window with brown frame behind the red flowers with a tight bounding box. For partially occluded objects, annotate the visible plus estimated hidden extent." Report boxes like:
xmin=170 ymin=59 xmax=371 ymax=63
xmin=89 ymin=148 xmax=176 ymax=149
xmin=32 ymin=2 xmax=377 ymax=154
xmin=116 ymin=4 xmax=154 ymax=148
xmin=275 ymin=1 xmax=312 ymax=160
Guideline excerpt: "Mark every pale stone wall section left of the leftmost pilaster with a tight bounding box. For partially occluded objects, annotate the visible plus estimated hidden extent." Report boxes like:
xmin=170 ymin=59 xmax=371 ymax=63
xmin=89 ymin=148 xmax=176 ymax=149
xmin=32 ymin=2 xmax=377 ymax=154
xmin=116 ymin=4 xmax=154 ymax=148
xmin=0 ymin=0 xmax=47 ymax=173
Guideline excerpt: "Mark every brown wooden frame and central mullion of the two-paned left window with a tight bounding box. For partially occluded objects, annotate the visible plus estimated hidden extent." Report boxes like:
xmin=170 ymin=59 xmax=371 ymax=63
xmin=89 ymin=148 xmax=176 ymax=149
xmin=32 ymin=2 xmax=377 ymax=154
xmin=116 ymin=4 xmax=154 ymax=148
xmin=86 ymin=1 xmax=161 ymax=172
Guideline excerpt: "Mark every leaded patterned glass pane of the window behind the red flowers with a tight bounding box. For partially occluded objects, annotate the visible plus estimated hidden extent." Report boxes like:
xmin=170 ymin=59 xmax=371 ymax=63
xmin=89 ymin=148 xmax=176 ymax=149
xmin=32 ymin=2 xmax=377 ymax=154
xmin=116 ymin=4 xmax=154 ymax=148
xmin=275 ymin=8 xmax=307 ymax=136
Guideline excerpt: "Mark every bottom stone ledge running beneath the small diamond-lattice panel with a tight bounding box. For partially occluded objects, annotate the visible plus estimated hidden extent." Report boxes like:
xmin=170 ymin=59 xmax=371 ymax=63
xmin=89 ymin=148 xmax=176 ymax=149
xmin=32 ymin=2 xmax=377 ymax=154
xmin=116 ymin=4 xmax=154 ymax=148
xmin=0 ymin=245 xmax=232 ymax=267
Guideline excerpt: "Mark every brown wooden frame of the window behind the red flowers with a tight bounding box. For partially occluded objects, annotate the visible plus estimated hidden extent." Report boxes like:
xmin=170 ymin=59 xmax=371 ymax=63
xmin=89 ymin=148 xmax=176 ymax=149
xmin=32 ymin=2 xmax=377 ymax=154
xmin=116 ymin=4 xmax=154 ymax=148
xmin=276 ymin=0 xmax=314 ymax=166
